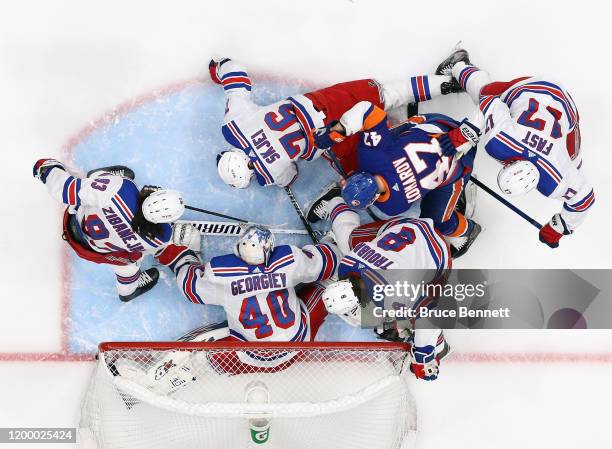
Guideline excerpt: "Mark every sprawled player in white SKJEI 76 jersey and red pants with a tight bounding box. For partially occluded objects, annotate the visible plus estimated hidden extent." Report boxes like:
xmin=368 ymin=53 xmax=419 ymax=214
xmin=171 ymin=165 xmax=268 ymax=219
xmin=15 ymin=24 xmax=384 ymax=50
xmin=210 ymin=59 xmax=460 ymax=189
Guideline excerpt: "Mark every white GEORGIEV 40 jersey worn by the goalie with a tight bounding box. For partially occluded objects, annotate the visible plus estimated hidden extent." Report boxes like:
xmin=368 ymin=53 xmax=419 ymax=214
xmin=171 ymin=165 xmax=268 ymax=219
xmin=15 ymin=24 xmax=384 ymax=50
xmin=176 ymin=244 xmax=338 ymax=341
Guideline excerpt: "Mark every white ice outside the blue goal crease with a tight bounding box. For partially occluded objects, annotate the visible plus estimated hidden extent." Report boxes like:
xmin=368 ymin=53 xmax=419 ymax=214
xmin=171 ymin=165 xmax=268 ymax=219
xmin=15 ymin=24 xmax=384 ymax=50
xmin=0 ymin=0 xmax=612 ymax=449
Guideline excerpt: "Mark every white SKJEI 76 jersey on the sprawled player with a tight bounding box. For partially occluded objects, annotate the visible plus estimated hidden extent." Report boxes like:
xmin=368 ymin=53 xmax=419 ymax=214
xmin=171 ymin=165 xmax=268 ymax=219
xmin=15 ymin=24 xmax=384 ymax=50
xmin=217 ymin=60 xmax=324 ymax=186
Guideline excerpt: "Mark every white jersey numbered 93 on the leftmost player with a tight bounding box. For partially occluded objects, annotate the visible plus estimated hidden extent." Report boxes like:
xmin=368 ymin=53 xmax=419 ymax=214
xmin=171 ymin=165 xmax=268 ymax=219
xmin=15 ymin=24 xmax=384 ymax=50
xmin=45 ymin=167 xmax=172 ymax=254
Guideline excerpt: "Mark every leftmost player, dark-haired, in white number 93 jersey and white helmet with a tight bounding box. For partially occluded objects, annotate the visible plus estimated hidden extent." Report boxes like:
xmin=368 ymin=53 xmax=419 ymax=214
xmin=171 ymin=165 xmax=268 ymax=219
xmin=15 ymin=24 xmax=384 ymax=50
xmin=34 ymin=159 xmax=199 ymax=301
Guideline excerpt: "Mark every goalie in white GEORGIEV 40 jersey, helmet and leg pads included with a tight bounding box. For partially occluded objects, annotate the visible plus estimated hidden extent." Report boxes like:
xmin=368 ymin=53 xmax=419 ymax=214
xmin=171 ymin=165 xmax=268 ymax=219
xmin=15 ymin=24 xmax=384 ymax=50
xmin=116 ymin=225 xmax=338 ymax=393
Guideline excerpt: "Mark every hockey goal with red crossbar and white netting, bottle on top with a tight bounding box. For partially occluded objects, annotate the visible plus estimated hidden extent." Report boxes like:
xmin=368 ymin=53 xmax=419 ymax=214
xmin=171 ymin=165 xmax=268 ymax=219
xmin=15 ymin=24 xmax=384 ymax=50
xmin=79 ymin=342 xmax=416 ymax=449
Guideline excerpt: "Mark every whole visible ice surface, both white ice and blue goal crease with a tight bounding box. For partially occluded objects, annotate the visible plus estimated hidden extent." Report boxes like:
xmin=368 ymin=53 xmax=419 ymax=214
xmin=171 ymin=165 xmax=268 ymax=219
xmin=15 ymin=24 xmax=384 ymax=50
xmin=0 ymin=0 xmax=612 ymax=449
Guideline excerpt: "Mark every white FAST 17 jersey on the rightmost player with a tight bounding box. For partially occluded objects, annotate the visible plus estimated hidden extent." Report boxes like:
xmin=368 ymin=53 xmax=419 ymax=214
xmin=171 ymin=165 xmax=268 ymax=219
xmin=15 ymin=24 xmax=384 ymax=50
xmin=478 ymin=76 xmax=595 ymax=230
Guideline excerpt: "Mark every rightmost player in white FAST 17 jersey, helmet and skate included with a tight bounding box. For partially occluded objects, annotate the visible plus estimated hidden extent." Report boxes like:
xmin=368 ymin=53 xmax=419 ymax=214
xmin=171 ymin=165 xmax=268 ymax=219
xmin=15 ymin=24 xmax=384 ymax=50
xmin=436 ymin=49 xmax=595 ymax=248
